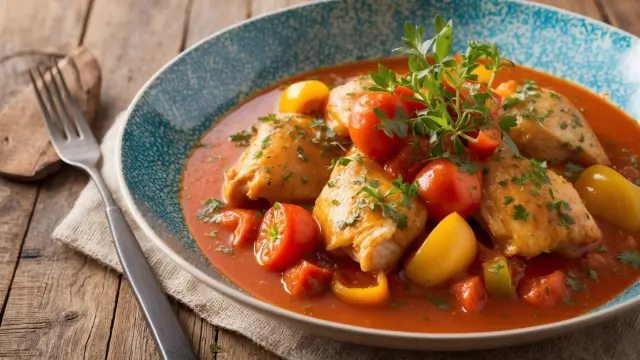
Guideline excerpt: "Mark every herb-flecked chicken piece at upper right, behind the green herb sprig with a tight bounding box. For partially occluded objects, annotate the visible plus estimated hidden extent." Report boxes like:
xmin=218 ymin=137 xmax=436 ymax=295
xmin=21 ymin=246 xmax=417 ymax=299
xmin=503 ymin=82 xmax=610 ymax=166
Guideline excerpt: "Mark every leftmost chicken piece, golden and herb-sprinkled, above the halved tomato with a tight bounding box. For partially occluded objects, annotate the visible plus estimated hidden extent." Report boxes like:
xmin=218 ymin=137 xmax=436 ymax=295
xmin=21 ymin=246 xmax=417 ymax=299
xmin=224 ymin=114 xmax=344 ymax=206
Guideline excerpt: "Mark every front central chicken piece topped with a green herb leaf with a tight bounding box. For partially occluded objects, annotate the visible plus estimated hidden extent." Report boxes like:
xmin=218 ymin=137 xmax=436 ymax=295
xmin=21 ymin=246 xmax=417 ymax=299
xmin=313 ymin=149 xmax=427 ymax=272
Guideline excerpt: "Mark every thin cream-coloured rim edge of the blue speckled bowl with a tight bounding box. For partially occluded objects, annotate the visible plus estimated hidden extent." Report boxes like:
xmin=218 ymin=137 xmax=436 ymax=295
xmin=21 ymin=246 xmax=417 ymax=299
xmin=115 ymin=0 xmax=640 ymax=340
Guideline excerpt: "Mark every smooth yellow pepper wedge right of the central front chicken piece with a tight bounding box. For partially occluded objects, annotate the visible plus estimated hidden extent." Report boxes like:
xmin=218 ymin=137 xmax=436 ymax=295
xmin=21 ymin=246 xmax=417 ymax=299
xmin=404 ymin=213 xmax=478 ymax=287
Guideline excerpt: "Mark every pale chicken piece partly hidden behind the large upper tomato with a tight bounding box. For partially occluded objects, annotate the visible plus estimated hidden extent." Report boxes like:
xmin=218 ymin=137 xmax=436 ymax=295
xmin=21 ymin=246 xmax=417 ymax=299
xmin=325 ymin=75 xmax=373 ymax=136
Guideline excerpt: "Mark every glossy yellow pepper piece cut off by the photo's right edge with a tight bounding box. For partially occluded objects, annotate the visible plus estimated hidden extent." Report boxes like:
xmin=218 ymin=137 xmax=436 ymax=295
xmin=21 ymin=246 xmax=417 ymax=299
xmin=574 ymin=165 xmax=640 ymax=232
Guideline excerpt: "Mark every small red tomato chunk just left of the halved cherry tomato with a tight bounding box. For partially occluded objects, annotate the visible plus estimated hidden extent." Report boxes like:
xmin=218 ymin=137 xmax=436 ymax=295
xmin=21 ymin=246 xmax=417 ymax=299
xmin=219 ymin=209 xmax=262 ymax=247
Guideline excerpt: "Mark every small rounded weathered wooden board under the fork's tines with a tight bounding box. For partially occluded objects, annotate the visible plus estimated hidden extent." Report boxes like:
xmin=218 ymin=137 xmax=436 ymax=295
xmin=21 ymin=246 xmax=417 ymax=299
xmin=0 ymin=47 xmax=102 ymax=181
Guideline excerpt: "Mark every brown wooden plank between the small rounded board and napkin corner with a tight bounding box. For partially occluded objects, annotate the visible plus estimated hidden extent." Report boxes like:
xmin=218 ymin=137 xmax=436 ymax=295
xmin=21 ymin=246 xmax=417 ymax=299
xmin=0 ymin=169 xmax=118 ymax=359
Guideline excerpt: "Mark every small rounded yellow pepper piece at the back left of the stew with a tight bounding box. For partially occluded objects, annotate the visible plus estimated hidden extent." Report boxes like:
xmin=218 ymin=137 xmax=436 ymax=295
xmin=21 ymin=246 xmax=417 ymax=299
xmin=279 ymin=80 xmax=329 ymax=114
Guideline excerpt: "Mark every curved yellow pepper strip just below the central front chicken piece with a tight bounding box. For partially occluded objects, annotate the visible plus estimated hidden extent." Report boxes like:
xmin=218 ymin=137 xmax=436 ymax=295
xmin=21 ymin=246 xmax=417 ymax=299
xmin=331 ymin=271 xmax=389 ymax=306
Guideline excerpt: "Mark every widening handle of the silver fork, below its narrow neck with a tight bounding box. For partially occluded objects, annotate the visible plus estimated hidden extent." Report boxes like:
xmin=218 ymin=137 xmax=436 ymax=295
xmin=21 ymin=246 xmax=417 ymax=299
xmin=107 ymin=205 xmax=197 ymax=360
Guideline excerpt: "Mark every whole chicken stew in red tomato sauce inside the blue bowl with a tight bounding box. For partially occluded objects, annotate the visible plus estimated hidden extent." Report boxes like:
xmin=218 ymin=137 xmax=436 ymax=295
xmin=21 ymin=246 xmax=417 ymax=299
xmin=180 ymin=17 xmax=640 ymax=332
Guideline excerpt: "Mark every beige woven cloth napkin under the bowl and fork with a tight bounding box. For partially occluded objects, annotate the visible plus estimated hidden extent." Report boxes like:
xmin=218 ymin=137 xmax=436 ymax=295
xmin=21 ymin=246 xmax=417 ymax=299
xmin=53 ymin=115 xmax=640 ymax=360
